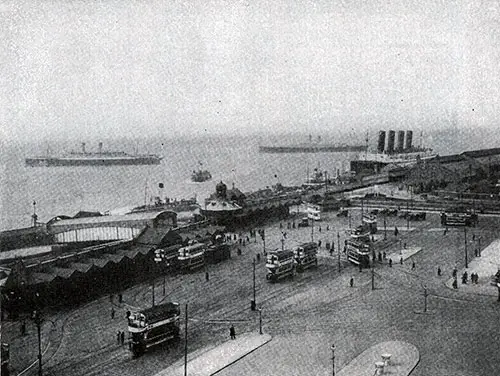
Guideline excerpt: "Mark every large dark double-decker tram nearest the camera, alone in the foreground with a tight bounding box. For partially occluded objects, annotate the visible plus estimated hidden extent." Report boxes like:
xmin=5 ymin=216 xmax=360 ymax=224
xmin=128 ymin=302 xmax=180 ymax=356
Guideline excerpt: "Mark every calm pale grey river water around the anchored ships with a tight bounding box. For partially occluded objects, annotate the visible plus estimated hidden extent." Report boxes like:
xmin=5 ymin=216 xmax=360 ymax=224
xmin=0 ymin=130 xmax=498 ymax=230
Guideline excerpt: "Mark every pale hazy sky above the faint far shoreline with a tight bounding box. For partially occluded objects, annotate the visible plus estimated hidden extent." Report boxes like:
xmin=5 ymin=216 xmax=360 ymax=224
xmin=0 ymin=0 xmax=500 ymax=139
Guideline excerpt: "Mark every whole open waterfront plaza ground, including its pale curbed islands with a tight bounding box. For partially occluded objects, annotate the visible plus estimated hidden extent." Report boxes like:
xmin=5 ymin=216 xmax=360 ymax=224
xmin=2 ymin=203 xmax=500 ymax=376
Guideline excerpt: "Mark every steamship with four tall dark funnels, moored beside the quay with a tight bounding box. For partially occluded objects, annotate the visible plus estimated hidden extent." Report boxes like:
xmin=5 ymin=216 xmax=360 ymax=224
xmin=351 ymin=130 xmax=437 ymax=173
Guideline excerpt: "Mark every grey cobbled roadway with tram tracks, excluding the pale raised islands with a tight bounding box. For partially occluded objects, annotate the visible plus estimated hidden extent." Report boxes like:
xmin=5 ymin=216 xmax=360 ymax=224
xmin=5 ymin=212 xmax=500 ymax=376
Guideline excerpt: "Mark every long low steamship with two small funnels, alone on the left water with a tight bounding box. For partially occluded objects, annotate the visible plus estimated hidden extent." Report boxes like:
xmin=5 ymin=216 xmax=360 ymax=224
xmin=25 ymin=142 xmax=163 ymax=167
